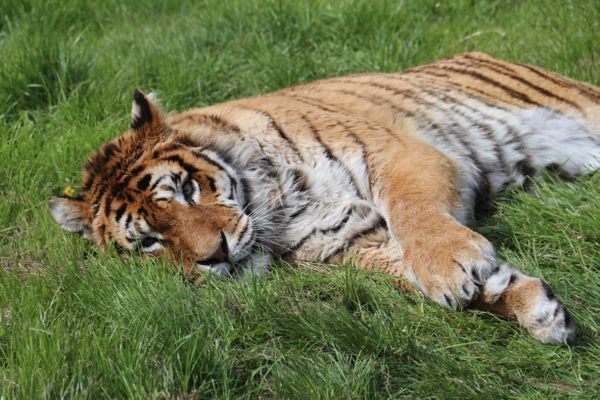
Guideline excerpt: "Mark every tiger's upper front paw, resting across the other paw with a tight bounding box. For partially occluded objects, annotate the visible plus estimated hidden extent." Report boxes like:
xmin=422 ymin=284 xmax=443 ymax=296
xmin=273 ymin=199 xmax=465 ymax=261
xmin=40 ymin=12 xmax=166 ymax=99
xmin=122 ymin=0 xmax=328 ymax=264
xmin=405 ymin=226 xmax=498 ymax=310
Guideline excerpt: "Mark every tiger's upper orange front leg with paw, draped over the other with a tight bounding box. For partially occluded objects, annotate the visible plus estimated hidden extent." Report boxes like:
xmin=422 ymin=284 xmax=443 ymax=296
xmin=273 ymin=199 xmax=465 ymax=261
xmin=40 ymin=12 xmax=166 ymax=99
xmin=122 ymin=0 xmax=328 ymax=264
xmin=374 ymin=141 xmax=498 ymax=310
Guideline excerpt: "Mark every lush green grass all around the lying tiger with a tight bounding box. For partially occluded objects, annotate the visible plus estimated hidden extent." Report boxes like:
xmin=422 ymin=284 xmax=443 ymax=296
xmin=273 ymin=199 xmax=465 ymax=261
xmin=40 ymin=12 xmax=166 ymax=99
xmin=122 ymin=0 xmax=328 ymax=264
xmin=0 ymin=0 xmax=600 ymax=399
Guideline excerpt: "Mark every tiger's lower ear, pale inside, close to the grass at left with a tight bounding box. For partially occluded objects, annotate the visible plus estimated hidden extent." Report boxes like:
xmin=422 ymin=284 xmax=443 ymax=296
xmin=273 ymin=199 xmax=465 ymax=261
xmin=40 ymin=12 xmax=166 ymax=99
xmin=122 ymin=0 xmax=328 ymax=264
xmin=48 ymin=197 xmax=92 ymax=240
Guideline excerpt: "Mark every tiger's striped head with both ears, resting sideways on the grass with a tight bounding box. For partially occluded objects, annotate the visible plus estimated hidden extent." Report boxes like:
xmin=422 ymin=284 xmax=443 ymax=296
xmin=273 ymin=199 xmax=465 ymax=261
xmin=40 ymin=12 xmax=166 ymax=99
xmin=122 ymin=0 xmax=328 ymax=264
xmin=49 ymin=90 xmax=270 ymax=279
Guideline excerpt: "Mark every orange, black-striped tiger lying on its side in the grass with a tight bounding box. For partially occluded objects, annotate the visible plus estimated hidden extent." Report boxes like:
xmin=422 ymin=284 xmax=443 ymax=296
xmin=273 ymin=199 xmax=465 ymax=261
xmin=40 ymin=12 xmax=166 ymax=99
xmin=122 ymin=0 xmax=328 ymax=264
xmin=49 ymin=53 xmax=600 ymax=343
